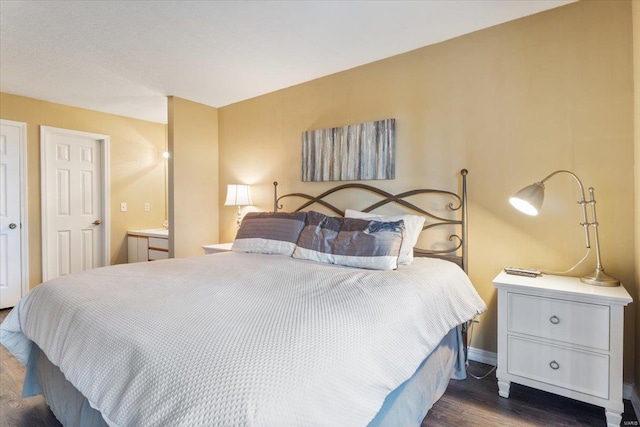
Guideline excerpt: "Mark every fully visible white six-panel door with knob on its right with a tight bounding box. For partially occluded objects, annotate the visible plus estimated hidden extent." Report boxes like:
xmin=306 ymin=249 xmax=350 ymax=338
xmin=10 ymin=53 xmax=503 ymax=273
xmin=41 ymin=127 xmax=106 ymax=280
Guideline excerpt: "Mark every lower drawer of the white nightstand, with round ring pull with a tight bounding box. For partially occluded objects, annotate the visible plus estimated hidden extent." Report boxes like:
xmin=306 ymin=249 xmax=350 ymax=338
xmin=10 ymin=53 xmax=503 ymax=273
xmin=507 ymin=336 xmax=609 ymax=399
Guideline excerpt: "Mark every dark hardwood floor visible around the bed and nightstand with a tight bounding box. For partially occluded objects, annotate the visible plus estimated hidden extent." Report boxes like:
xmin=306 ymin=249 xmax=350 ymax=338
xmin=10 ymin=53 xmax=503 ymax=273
xmin=0 ymin=310 xmax=639 ymax=427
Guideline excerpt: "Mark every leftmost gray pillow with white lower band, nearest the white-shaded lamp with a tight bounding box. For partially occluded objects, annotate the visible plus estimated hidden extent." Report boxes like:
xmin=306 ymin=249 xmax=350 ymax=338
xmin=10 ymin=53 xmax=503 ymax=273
xmin=231 ymin=212 xmax=307 ymax=256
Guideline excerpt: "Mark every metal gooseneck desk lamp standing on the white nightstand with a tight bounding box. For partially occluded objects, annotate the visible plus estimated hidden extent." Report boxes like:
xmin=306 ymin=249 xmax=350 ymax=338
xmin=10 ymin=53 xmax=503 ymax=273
xmin=509 ymin=170 xmax=620 ymax=286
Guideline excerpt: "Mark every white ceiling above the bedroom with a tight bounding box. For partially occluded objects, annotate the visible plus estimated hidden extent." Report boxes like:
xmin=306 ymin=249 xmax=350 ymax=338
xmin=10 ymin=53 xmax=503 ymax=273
xmin=0 ymin=0 xmax=572 ymax=123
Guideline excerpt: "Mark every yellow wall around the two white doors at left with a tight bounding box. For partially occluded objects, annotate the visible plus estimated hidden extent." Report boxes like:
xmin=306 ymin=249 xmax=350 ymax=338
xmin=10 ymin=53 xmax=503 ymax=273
xmin=0 ymin=93 xmax=166 ymax=287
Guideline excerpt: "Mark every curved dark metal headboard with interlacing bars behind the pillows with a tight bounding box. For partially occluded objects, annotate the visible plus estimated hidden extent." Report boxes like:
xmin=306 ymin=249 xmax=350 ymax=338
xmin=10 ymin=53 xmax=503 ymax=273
xmin=273 ymin=169 xmax=469 ymax=273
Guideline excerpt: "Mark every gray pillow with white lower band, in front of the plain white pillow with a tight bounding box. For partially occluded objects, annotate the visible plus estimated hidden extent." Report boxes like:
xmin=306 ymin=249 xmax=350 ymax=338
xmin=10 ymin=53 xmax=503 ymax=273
xmin=293 ymin=211 xmax=405 ymax=270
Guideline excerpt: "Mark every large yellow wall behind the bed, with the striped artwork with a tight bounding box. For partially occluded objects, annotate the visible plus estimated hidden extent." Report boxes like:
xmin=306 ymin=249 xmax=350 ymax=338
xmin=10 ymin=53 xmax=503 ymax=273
xmin=219 ymin=1 xmax=638 ymax=382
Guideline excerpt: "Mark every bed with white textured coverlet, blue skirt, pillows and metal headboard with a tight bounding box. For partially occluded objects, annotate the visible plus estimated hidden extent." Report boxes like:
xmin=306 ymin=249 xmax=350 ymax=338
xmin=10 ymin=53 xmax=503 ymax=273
xmin=0 ymin=170 xmax=486 ymax=426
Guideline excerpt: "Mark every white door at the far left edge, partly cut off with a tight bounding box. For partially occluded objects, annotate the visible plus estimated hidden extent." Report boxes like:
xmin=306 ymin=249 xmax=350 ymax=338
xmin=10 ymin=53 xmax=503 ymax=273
xmin=0 ymin=121 xmax=26 ymax=308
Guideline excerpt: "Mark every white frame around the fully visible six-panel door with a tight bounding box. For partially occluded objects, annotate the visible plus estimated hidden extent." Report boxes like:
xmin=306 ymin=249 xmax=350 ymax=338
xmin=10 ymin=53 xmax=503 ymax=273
xmin=40 ymin=126 xmax=111 ymax=282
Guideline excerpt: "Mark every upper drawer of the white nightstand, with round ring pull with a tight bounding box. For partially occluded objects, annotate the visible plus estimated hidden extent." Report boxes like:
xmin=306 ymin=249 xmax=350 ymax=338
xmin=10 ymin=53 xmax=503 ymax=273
xmin=508 ymin=292 xmax=609 ymax=351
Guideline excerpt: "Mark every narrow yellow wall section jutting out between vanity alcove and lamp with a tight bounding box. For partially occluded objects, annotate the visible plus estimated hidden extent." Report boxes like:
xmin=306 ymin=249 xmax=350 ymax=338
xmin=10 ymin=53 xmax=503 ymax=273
xmin=168 ymin=97 xmax=219 ymax=258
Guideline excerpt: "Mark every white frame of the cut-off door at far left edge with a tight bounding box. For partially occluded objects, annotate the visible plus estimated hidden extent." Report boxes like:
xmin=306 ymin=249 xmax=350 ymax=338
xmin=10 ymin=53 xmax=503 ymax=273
xmin=0 ymin=119 xmax=29 ymax=296
